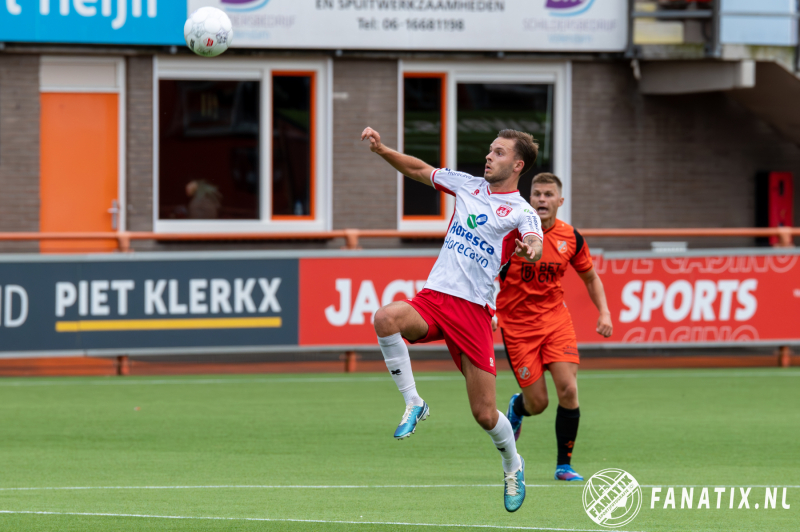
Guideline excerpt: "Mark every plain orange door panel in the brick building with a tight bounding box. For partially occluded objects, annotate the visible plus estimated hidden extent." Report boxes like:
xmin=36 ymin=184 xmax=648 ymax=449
xmin=39 ymin=93 xmax=119 ymax=252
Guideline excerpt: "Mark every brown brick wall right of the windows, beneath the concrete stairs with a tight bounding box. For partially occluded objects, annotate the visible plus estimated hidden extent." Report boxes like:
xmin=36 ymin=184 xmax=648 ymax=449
xmin=572 ymin=62 xmax=800 ymax=249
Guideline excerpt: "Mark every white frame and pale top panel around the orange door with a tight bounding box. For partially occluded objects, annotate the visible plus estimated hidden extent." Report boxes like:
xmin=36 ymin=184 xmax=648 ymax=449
xmin=39 ymin=55 xmax=128 ymax=232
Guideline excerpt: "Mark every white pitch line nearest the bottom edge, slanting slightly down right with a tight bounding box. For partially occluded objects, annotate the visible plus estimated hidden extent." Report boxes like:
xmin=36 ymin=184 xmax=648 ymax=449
xmin=0 ymin=510 xmax=640 ymax=532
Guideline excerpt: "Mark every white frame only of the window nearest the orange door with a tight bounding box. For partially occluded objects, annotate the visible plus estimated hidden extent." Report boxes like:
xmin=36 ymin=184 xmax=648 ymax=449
xmin=153 ymin=56 xmax=333 ymax=233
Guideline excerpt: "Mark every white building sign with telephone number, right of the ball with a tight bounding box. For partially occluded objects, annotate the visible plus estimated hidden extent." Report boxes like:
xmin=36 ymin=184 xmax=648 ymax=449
xmin=189 ymin=0 xmax=628 ymax=51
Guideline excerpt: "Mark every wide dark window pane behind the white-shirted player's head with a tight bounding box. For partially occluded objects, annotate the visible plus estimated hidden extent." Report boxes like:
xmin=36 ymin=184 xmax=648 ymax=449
xmin=457 ymin=83 xmax=553 ymax=202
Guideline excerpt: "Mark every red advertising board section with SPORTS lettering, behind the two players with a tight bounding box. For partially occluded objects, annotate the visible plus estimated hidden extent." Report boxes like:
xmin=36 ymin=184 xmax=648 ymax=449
xmin=300 ymin=252 xmax=800 ymax=347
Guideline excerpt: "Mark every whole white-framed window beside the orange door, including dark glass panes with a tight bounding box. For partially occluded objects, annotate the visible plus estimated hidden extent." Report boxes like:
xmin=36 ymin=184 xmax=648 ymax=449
xmin=154 ymin=58 xmax=330 ymax=232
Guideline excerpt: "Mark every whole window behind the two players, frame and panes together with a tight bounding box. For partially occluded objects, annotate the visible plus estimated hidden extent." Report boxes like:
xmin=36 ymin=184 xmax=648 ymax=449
xmin=398 ymin=61 xmax=572 ymax=231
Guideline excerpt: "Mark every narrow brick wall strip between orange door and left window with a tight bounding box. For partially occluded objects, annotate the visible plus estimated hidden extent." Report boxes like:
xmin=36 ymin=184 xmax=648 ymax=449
xmin=126 ymin=56 xmax=153 ymax=231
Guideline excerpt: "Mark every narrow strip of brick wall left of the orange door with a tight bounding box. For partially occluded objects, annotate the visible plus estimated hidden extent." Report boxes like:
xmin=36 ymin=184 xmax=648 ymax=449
xmin=0 ymin=55 xmax=39 ymax=251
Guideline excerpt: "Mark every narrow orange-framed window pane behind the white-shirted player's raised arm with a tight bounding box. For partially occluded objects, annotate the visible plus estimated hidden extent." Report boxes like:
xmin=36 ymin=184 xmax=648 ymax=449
xmin=403 ymin=72 xmax=447 ymax=220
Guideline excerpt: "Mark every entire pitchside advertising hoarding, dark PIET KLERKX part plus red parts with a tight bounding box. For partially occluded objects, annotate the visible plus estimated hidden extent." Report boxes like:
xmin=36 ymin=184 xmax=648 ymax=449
xmin=0 ymin=250 xmax=800 ymax=356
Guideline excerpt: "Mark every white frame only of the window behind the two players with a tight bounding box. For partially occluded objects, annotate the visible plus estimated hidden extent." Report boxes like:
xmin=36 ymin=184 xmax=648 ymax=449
xmin=397 ymin=61 xmax=572 ymax=231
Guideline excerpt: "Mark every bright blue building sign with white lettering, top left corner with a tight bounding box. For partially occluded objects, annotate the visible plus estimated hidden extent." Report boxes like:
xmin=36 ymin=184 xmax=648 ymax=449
xmin=0 ymin=0 xmax=186 ymax=45
